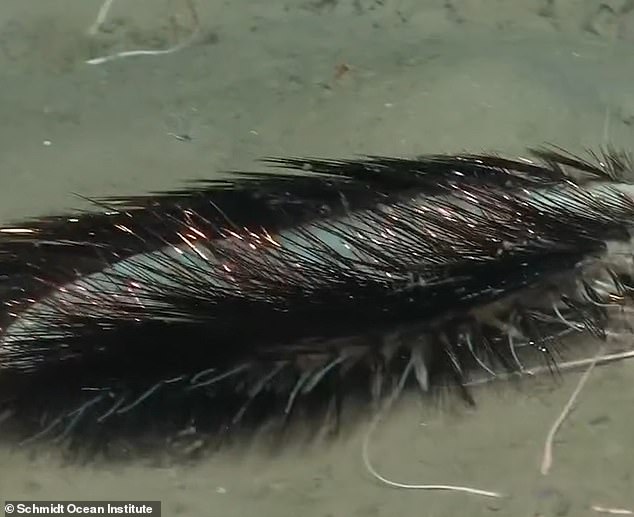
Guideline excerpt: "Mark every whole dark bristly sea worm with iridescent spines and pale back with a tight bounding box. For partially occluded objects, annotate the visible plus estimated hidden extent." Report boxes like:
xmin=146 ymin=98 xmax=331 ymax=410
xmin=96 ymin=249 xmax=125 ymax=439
xmin=0 ymin=145 xmax=634 ymax=456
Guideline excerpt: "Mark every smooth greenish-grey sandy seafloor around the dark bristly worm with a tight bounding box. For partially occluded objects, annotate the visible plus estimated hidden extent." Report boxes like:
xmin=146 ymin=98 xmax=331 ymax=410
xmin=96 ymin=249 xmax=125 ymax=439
xmin=0 ymin=0 xmax=634 ymax=517
